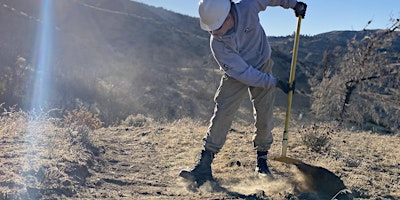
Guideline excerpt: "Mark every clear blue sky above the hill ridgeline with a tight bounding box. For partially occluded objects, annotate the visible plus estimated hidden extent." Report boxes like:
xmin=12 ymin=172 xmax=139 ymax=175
xmin=134 ymin=0 xmax=400 ymax=36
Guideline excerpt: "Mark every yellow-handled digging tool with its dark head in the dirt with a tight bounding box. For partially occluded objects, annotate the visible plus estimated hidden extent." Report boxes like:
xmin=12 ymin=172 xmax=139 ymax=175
xmin=273 ymin=16 xmax=353 ymax=199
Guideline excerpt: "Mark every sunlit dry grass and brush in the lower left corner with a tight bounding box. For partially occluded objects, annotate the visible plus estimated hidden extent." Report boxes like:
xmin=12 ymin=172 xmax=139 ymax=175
xmin=0 ymin=106 xmax=99 ymax=199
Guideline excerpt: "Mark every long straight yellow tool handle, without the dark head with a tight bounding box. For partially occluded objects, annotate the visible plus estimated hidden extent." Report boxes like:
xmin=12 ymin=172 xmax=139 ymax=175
xmin=282 ymin=16 xmax=302 ymax=157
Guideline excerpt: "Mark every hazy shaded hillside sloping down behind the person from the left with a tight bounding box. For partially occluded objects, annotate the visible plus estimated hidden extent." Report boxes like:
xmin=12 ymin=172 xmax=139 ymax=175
xmin=0 ymin=0 xmax=308 ymax=123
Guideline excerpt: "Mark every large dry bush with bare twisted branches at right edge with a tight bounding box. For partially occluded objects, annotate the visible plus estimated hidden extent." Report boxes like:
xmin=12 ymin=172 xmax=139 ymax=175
xmin=312 ymin=20 xmax=400 ymax=132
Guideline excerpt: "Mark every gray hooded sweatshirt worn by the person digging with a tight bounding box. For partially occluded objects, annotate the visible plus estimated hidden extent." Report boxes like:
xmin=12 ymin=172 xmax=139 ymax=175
xmin=210 ymin=0 xmax=297 ymax=88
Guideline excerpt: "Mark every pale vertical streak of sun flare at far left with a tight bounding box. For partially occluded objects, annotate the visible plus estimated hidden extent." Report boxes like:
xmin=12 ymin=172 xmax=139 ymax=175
xmin=24 ymin=0 xmax=53 ymax=189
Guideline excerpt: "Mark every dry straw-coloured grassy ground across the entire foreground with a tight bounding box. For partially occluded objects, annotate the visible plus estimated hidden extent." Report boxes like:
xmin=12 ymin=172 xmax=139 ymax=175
xmin=0 ymin=105 xmax=400 ymax=199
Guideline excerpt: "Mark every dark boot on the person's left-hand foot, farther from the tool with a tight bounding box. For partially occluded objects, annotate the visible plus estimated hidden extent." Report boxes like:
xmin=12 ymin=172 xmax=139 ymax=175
xmin=179 ymin=150 xmax=214 ymax=186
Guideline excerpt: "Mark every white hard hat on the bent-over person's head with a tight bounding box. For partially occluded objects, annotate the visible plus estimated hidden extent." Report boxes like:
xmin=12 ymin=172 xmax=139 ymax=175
xmin=199 ymin=0 xmax=231 ymax=31
